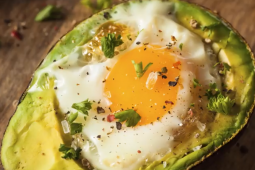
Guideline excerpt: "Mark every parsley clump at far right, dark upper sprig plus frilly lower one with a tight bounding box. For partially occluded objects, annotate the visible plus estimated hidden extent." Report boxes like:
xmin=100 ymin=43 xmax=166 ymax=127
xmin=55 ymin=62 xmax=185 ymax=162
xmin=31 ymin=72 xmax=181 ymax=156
xmin=205 ymin=83 xmax=235 ymax=114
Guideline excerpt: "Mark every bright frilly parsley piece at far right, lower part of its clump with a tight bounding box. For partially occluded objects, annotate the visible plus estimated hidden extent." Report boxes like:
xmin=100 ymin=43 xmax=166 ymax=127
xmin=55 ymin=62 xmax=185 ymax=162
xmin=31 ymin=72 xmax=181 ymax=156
xmin=207 ymin=93 xmax=235 ymax=114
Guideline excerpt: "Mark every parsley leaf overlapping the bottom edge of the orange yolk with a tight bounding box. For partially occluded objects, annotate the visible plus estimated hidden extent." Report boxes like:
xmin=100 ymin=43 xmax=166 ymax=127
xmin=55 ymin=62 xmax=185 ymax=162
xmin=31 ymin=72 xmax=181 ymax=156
xmin=114 ymin=109 xmax=141 ymax=127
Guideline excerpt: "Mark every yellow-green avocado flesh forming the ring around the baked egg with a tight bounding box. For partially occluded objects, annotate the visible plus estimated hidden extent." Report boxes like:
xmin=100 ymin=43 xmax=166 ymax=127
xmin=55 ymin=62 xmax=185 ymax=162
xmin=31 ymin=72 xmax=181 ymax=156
xmin=1 ymin=1 xmax=255 ymax=170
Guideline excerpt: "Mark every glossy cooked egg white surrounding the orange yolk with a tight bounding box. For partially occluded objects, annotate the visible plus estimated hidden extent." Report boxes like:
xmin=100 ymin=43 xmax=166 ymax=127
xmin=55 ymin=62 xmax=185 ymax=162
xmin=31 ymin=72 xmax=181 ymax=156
xmin=30 ymin=1 xmax=220 ymax=170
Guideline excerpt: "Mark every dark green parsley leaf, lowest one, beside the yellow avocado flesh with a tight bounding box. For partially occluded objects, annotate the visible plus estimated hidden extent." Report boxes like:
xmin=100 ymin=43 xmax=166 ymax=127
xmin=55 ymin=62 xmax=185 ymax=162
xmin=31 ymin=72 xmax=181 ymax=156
xmin=58 ymin=144 xmax=81 ymax=160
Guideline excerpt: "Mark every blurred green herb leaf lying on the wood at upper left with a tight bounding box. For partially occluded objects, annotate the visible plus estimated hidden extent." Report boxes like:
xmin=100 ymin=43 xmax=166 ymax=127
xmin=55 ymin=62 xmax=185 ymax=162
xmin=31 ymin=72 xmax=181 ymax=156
xmin=35 ymin=5 xmax=63 ymax=21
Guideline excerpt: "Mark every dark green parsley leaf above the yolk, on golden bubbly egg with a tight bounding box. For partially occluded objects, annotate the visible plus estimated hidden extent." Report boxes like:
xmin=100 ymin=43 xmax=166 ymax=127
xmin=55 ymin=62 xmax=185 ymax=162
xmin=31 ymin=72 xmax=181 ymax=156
xmin=101 ymin=33 xmax=123 ymax=58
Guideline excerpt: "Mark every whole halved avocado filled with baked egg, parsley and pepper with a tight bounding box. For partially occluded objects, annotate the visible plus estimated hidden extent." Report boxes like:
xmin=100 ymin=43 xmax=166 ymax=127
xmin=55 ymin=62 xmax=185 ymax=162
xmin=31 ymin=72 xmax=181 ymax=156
xmin=1 ymin=1 xmax=255 ymax=170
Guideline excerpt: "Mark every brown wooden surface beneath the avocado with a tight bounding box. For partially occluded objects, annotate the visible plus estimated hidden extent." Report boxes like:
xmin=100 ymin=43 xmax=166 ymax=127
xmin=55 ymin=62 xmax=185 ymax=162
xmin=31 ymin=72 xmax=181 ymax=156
xmin=0 ymin=0 xmax=255 ymax=170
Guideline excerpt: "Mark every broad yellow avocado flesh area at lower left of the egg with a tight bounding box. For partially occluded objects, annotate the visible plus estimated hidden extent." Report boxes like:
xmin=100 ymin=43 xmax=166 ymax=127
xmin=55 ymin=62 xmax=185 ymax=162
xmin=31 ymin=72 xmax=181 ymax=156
xmin=1 ymin=79 xmax=82 ymax=170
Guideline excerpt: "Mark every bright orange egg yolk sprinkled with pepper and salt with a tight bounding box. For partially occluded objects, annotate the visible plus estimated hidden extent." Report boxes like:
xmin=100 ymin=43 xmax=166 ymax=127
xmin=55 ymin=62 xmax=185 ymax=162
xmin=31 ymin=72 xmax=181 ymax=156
xmin=104 ymin=46 xmax=181 ymax=125
